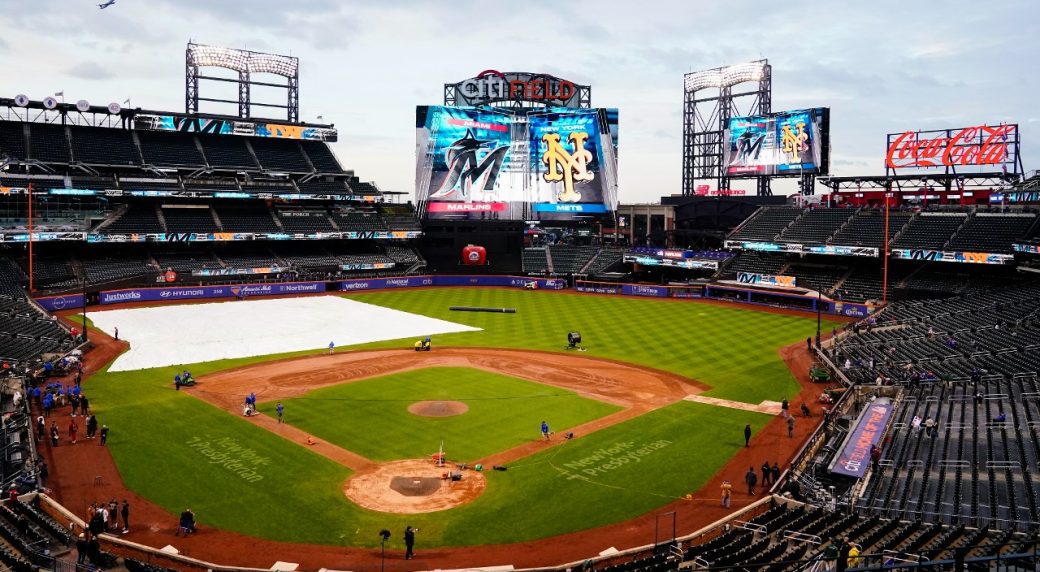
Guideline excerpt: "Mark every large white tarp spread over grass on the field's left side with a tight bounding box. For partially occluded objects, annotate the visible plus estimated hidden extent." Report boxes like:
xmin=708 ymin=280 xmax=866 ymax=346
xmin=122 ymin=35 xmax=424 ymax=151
xmin=90 ymin=296 xmax=479 ymax=371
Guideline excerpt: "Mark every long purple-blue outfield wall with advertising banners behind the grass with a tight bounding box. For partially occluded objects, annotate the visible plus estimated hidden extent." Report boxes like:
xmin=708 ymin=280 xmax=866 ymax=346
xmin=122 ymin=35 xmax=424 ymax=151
xmin=35 ymin=275 xmax=874 ymax=318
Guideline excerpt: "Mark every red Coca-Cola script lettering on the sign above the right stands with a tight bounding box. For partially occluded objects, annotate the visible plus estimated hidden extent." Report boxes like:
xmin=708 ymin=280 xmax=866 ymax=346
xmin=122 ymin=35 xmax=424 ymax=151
xmin=885 ymin=125 xmax=1016 ymax=168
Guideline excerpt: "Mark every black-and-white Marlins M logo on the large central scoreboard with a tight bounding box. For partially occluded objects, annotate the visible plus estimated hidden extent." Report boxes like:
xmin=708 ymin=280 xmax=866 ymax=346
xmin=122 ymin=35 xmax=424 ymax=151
xmin=430 ymin=130 xmax=510 ymax=200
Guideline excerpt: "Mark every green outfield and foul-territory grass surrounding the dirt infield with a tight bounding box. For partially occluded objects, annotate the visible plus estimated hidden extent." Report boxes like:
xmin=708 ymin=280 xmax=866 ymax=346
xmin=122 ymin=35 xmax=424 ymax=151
xmin=79 ymin=288 xmax=831 ymax=548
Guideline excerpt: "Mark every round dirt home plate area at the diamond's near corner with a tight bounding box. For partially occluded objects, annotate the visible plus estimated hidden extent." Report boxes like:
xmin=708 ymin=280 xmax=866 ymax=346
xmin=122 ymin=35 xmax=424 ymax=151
xmin=343 ymin=460 xmax=486 ymax=515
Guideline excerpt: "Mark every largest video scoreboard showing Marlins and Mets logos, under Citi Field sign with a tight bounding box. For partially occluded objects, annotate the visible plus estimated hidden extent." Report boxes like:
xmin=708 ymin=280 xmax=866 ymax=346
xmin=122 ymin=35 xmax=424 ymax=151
xmin=415 ymin=106 xmax=618 ymax=220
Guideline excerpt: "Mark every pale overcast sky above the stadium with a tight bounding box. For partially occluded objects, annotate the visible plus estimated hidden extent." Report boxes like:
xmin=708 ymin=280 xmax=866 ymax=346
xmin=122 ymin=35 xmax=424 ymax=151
xmin=0 ymin=0 xmax=1040 ymax=202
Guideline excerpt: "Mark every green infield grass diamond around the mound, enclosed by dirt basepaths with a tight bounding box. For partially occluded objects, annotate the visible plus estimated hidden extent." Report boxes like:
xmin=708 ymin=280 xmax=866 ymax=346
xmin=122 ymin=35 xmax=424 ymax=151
xmin=259 ymin=367 xmax=621 ymax=461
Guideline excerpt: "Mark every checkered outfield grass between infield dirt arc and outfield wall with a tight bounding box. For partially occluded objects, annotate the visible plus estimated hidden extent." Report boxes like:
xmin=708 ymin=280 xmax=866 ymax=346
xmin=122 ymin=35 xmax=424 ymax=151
xmin=345 ymin=287 xmax=837 ymax=404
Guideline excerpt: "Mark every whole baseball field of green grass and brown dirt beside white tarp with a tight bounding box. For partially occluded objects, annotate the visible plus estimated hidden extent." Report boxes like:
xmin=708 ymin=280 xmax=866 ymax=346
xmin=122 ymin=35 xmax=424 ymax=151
xmin=76 ymin=288 xmax=833 ymax=546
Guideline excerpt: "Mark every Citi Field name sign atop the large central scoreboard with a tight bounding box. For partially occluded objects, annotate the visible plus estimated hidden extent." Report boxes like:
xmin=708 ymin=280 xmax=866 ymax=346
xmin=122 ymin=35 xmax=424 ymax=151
xmin=448 ymin=70 xmax=588 ymax=107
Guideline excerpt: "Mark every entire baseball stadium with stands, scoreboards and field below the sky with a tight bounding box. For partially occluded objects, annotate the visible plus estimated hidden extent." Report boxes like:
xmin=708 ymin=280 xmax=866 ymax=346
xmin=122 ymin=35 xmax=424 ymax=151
xmin=0 ymin=17 xmax=1040 ymax=572
